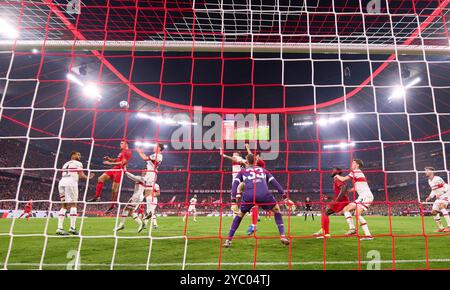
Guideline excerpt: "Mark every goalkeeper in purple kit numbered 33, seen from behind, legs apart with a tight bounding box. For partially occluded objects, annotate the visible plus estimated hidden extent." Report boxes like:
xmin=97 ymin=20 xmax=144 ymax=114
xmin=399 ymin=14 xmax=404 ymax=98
xmin=224 ymin=154 xmax=289 ymax=248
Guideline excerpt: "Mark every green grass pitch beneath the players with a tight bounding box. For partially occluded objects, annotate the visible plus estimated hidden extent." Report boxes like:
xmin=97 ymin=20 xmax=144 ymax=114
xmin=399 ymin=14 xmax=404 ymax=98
xmin=0 ymin=216 xmax=450 ymax=270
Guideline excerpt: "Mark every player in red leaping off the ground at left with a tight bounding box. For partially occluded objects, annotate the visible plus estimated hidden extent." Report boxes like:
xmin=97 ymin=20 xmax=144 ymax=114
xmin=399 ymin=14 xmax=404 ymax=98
xmin=89 ymin=140 xmax=132 ymax=213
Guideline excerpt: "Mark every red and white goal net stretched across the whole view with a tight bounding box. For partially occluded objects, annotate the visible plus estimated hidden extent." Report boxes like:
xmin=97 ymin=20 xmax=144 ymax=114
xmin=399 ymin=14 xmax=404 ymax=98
xmin=0 ymin=0 xmax=450 ymax=270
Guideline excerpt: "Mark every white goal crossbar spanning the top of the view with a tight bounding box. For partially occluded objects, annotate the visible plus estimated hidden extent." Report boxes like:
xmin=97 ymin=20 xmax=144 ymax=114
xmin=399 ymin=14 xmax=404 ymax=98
xmin=0 ymin=40 xmax=450 ymax=55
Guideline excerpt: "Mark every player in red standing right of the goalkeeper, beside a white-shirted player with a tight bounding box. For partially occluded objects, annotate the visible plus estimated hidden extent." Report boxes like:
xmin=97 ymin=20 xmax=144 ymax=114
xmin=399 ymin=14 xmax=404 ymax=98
xmin=314 ymin=167 xmax=350 ymax=239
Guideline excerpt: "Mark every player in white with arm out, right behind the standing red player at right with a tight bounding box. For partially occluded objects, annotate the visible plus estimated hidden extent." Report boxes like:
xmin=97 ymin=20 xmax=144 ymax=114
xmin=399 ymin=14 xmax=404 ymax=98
xmin=336 ymin=159 xmax=373 ymax=241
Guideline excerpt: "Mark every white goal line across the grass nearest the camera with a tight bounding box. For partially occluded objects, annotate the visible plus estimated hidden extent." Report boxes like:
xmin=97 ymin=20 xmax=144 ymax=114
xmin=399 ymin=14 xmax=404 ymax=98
xmin=0 ymin=259 xmax=450 ymax=267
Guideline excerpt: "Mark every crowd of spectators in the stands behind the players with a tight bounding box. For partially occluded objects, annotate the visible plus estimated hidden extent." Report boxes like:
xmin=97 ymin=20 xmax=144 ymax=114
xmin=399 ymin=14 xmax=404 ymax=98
xmin=0 ymin=139 xmax=446 ymax=215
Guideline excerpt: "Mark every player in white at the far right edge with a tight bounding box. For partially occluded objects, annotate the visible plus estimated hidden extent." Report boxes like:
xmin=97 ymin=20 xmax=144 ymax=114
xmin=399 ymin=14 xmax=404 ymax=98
xmin=425 ymin=167 xmax=450 ymax=232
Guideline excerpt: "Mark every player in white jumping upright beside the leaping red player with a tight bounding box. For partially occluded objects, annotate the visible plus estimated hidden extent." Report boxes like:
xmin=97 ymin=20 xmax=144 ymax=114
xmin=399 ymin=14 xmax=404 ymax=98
xmin=137 ymin=143 xmax=164 ymax=224
